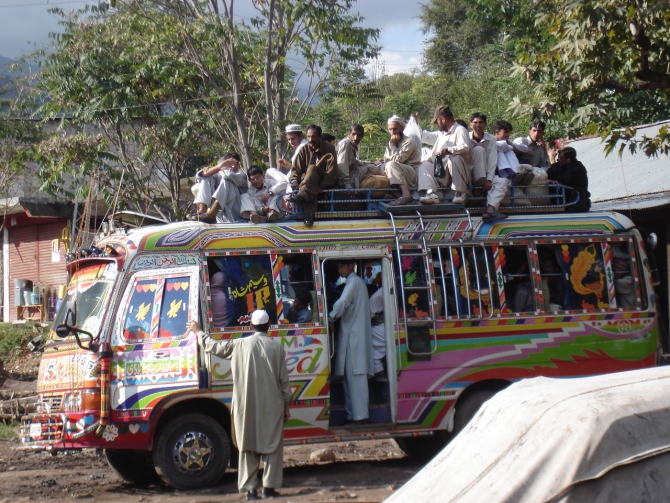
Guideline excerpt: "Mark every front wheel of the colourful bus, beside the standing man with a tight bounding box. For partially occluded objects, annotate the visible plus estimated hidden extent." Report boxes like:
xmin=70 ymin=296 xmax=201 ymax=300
xmin=153 ymin=414 xmax=230 ymax=489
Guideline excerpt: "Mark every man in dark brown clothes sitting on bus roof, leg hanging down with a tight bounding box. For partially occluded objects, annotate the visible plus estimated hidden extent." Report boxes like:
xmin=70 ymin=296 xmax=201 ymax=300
xmin=289 ymin=124 xmax=339 ymax=227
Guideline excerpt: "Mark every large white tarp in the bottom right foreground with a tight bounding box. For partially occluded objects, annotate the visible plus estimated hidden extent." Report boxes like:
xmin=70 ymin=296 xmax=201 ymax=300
xmin=386 ymin=367 xmax=670 ymax=503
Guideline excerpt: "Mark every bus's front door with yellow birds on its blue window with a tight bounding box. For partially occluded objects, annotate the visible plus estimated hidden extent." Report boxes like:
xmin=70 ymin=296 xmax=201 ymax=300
xmin=110 ymin=266 xmax=199 ymax=424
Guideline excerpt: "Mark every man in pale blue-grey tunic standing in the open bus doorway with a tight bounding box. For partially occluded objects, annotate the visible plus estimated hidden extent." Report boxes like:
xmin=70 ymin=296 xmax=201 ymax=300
xmin=328 ymin=260 xmax=375 ymax=426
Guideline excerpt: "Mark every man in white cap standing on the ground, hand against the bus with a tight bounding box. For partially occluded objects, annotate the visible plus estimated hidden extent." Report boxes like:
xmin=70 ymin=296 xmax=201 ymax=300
xmin=188 ymin=310 xmax=291 ymax=500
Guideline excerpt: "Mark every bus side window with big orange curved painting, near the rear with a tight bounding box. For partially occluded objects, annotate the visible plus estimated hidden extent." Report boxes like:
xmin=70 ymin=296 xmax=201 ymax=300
xmin=537 ymin=243 xmax=610 ymax=311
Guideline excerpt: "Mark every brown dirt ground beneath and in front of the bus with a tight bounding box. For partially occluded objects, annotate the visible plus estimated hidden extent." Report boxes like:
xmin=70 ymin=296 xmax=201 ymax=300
xmin=0 ymin=379 xmax=422 ymax=503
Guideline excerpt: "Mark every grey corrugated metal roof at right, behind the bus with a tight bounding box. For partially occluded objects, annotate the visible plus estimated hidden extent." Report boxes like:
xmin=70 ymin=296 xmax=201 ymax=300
xmin=569 ymin=121 xmax=670 ymax=206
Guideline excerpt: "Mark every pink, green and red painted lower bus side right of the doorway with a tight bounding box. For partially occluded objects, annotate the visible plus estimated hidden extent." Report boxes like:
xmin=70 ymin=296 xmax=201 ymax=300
xmin=398 ymin=312 xmax=658 ymax=429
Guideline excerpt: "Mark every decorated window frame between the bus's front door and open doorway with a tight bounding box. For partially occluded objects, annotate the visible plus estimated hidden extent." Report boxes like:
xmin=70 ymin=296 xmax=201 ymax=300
xmin=202 ymin=248 xmax=327 ymax=339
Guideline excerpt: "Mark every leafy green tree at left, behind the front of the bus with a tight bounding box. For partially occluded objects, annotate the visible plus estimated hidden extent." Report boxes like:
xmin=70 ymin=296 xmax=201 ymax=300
xmin=38 ymin=3 xmax=226 ymax=219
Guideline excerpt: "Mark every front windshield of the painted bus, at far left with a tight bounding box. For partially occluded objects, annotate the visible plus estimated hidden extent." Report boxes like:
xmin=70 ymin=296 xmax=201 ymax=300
xmin=52 ymin=262 xmax=117 ymax=338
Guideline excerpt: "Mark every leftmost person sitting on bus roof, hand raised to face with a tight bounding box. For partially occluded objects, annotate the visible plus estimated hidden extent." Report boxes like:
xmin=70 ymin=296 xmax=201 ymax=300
xmin=192 ymin=153 xmax=247 ymax=224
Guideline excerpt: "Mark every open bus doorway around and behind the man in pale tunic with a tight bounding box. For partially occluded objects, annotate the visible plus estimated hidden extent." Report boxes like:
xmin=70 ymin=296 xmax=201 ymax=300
xmin=319 ymin=249 xmax=397 ymax=429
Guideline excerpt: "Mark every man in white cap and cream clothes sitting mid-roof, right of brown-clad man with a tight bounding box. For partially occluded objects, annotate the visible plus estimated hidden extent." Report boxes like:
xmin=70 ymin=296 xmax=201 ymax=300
xmin=380 ymin=115 xmax=421 ymax=206
